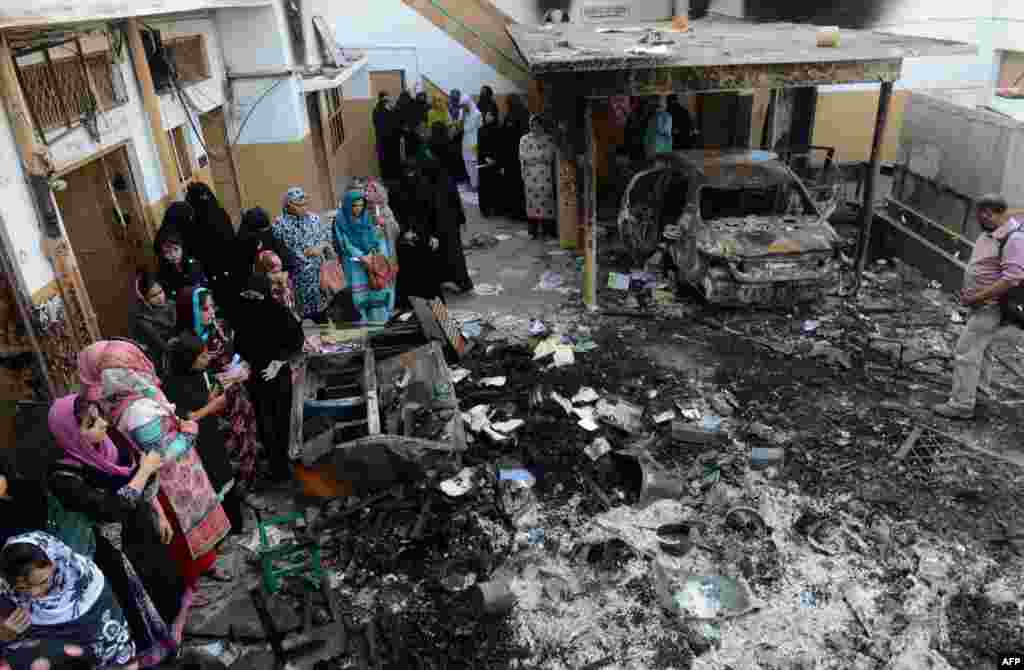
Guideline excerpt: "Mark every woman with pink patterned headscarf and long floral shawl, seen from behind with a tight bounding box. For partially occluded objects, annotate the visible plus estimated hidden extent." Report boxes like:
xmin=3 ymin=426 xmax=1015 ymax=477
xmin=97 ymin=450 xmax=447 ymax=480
xmin=78 ymin=340 xmax=231 ymax=622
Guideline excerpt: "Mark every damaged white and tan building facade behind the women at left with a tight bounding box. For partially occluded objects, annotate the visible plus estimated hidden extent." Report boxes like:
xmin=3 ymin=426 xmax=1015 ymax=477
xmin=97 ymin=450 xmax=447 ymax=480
xmin=0 ymin=0 xmax=370 ymax=436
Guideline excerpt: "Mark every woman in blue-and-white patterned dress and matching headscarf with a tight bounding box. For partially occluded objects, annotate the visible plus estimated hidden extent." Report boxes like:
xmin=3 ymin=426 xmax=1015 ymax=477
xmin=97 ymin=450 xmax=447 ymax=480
xmin=273 ymin=186 xmax=331 ymax=322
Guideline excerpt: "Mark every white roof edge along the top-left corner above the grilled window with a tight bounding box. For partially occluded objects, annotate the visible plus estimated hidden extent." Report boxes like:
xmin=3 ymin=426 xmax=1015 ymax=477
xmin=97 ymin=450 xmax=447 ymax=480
xmin=0 ymin=0 xmax=273 ymax=31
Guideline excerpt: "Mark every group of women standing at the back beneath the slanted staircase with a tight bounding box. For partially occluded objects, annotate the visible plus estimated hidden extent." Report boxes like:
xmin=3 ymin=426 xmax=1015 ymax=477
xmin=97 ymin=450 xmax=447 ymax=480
xmin=374 ymin=86 xmax=556 ymax=238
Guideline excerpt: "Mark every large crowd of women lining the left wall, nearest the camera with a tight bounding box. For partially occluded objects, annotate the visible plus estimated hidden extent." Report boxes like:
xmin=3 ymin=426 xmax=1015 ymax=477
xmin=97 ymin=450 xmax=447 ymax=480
xmin=0 ymin=172 xmax=448 ymax=669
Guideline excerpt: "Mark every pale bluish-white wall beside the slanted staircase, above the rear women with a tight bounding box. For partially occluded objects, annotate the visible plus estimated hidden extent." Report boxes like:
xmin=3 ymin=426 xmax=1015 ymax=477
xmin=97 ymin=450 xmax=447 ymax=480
xmin=326 ymin=0 xmax=520 ymax=93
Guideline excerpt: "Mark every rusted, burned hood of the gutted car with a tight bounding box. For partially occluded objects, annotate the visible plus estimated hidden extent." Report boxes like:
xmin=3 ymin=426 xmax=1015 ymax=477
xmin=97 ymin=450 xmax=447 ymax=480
xmin=696 ymin=216 xmax=839 ymax=258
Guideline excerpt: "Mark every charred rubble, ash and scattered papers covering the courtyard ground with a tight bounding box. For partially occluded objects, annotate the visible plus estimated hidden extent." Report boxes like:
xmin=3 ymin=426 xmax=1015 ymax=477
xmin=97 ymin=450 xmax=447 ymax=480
xmin=186 ymin=248 xmax=1024 ymax=670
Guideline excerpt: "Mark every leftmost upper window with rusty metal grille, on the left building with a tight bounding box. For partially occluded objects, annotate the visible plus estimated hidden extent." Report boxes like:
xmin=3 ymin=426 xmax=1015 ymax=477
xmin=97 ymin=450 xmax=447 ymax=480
xmin=17 ymin=51 xmax=128 ymax=130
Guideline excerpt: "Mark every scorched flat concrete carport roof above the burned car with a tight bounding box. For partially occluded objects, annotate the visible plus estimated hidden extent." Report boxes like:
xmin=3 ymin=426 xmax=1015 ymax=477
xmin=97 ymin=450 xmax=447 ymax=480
xmin=507 ymin=17 xmax=977 ymax=97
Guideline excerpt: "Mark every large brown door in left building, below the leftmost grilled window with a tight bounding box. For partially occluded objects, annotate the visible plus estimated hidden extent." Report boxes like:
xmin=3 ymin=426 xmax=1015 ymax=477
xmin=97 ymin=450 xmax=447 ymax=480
xmin=54 ymin=145 xmax=151 ymax=337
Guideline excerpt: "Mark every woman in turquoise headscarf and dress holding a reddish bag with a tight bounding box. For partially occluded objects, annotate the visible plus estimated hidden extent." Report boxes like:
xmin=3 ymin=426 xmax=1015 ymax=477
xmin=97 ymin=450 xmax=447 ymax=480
xmin=334 ymin=191 xmax=398 ymax=323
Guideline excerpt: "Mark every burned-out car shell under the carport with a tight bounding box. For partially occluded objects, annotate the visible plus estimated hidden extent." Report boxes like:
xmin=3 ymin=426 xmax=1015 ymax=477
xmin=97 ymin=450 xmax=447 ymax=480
xmin=618 ymin=150 xmax=841 ymax=306
